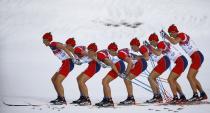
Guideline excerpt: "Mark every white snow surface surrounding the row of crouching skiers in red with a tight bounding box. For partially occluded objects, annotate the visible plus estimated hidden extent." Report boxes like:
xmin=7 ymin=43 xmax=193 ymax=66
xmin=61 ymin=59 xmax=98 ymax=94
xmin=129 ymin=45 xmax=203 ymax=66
xmin=0 ymin=0 xmax=210 ymax=113
